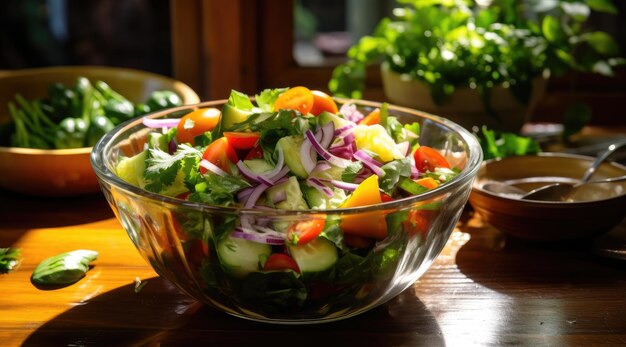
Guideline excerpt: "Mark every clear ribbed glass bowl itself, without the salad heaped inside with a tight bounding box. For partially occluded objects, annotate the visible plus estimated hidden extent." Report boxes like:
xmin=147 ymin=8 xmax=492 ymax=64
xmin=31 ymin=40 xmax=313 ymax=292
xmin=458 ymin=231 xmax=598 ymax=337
xmin=91 ymin=100 xmax=482 ymax=324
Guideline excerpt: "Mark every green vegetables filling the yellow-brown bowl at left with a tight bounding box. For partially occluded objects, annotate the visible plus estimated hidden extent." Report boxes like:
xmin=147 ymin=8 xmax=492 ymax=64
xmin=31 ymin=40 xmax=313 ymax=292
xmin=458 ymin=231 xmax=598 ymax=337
xmin=0 ymin=77 xmax=182 ymax=149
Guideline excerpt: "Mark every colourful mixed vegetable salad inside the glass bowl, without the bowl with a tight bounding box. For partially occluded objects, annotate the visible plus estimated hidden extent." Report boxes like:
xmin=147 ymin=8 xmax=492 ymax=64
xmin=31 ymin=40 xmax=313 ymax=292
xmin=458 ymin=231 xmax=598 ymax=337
xmin=115 ymin=86 xmax=459 ymax=314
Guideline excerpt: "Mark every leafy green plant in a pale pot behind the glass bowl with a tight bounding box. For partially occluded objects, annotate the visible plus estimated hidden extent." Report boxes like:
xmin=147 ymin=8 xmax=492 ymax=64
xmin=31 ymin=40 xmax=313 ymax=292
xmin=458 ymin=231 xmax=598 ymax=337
xmin=329 ymin=0 xmax=624 ymax=132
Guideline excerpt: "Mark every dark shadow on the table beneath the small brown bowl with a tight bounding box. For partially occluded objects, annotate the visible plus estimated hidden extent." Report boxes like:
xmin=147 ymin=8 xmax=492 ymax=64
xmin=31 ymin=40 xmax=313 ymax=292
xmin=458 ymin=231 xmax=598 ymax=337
xmin=456 ymin=213 xmax=624 ymax=292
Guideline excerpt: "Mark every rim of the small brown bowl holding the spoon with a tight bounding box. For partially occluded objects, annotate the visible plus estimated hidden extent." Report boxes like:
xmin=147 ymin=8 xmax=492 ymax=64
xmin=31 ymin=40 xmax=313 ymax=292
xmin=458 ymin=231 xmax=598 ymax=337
xmin=472 ymin=152 xmax=626 ymax=208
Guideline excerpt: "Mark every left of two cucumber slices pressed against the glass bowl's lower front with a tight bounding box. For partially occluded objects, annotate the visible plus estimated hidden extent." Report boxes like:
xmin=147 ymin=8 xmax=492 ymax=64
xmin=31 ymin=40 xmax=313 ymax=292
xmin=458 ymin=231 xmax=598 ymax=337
xmin=216 ymin=234 xmax=272 ymax=277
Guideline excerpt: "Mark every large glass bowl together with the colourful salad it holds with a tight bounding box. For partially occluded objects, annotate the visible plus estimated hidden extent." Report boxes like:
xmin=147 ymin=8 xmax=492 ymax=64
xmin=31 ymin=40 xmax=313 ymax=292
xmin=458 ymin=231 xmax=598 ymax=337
xmin=92 ymin=87 xmax=482 ymax=324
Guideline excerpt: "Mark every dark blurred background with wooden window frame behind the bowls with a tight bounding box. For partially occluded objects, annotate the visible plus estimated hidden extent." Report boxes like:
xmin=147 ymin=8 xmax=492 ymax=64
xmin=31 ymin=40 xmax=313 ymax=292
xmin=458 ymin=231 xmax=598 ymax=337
xmin=0 ymin=0 xmax=626 ymax=125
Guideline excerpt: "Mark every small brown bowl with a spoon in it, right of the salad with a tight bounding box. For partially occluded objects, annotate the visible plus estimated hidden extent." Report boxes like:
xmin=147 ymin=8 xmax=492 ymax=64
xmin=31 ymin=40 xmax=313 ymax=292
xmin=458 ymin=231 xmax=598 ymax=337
xmin=469 ymin=153 xmax=626 ymax=241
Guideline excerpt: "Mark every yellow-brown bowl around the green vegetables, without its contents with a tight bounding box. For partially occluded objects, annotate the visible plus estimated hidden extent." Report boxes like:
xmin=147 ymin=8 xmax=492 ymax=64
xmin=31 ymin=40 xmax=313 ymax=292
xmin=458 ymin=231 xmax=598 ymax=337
xmin=0 ymin=66 xmax=200 ymax=196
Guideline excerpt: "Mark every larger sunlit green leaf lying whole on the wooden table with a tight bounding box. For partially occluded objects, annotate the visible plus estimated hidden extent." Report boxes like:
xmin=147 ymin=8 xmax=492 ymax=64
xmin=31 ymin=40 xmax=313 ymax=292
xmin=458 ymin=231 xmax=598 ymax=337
xmin=31 ymin=249 xmax=98 ymax=285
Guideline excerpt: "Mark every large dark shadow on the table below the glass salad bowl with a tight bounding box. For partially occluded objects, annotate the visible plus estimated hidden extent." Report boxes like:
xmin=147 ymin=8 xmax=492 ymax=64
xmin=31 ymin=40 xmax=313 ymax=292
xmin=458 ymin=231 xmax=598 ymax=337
xmin=24 ymin=277 xmax=445 ymax=347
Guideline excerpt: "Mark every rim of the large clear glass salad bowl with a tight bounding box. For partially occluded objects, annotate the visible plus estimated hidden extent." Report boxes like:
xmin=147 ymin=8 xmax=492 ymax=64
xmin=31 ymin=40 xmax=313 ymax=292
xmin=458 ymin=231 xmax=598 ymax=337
xmin=90 ymin=97 xmax=483 ymax=216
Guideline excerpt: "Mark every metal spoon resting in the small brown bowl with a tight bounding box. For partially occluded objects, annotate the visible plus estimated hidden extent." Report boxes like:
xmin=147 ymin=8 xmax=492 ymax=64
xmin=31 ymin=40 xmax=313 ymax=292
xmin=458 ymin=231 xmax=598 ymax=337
xmin=522 ymin=142 xmax=626 ymax=201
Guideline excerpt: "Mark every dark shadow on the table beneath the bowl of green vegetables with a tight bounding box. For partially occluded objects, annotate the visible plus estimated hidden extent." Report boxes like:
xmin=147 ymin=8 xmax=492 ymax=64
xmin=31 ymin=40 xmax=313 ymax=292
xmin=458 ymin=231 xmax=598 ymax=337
xmin=0 ymin=190 xmax=114 ymax=229
